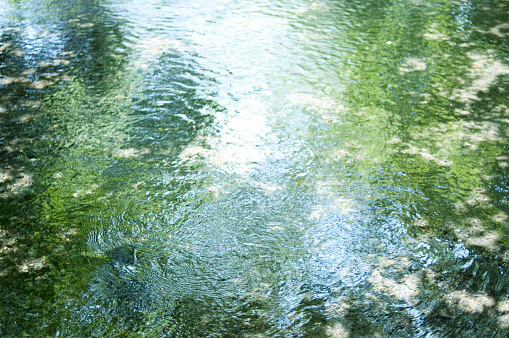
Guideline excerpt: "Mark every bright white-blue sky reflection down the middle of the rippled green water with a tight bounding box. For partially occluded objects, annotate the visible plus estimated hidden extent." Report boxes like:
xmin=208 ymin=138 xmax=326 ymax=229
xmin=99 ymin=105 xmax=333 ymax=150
xmin=64 ymin=2 xmax=404 ymax=335
